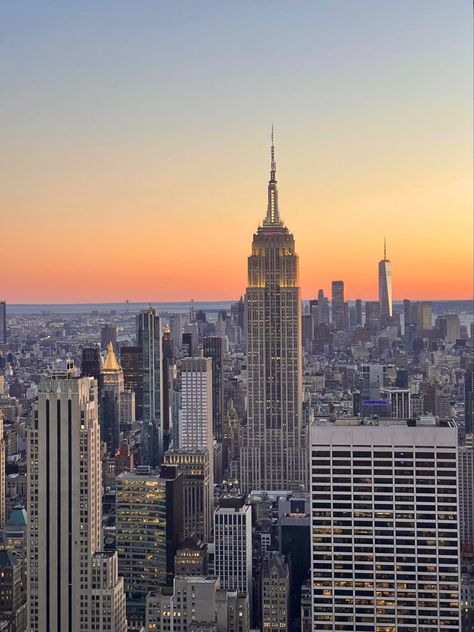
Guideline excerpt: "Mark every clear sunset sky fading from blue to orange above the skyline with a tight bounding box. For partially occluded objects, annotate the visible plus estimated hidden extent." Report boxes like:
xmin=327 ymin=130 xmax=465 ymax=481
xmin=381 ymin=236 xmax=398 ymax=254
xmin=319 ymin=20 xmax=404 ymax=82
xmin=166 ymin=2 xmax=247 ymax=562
xmin=0 ymin=0 xmax=473 ymax=303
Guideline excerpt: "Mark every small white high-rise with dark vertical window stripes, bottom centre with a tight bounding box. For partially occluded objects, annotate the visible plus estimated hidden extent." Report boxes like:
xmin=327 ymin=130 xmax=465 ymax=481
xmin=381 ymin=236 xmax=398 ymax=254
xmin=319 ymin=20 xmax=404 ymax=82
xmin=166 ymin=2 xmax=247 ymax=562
xmin=214 ymin=496 xmax=252 ymax=603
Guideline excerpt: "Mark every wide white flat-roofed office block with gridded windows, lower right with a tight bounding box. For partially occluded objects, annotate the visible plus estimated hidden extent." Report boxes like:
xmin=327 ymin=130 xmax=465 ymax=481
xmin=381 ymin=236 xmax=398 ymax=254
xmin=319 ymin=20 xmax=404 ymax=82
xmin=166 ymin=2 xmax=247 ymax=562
xmin=310 ymin=419 xmax=460 ymax=632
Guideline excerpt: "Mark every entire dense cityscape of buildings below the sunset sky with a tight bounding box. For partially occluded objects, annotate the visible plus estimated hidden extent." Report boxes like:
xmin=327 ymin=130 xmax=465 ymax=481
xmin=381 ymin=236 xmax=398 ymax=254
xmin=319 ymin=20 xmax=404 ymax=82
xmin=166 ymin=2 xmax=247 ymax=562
xmin=0 ymin=135 xmax=474 ymax=632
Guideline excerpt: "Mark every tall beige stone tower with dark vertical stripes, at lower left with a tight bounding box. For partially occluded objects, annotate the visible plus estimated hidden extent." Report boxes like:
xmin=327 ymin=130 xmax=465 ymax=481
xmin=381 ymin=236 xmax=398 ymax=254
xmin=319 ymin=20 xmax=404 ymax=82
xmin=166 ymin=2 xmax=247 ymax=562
xmin=27 ymin=367 xmax=126 ymax=632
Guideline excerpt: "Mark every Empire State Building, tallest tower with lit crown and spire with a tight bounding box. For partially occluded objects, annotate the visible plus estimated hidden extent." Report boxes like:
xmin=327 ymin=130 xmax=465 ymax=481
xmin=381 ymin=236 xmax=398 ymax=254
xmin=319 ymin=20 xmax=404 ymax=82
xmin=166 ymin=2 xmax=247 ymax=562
xmin=240 ymin=134 xmax=306 ymax=492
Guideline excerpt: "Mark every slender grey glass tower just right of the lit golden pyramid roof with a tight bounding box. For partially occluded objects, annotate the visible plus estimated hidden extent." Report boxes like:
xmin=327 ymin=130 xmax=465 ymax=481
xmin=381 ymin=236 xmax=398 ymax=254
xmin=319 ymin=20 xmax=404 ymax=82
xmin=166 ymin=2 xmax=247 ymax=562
xmin=137 ymin=307 xmax=163 ymax=466
